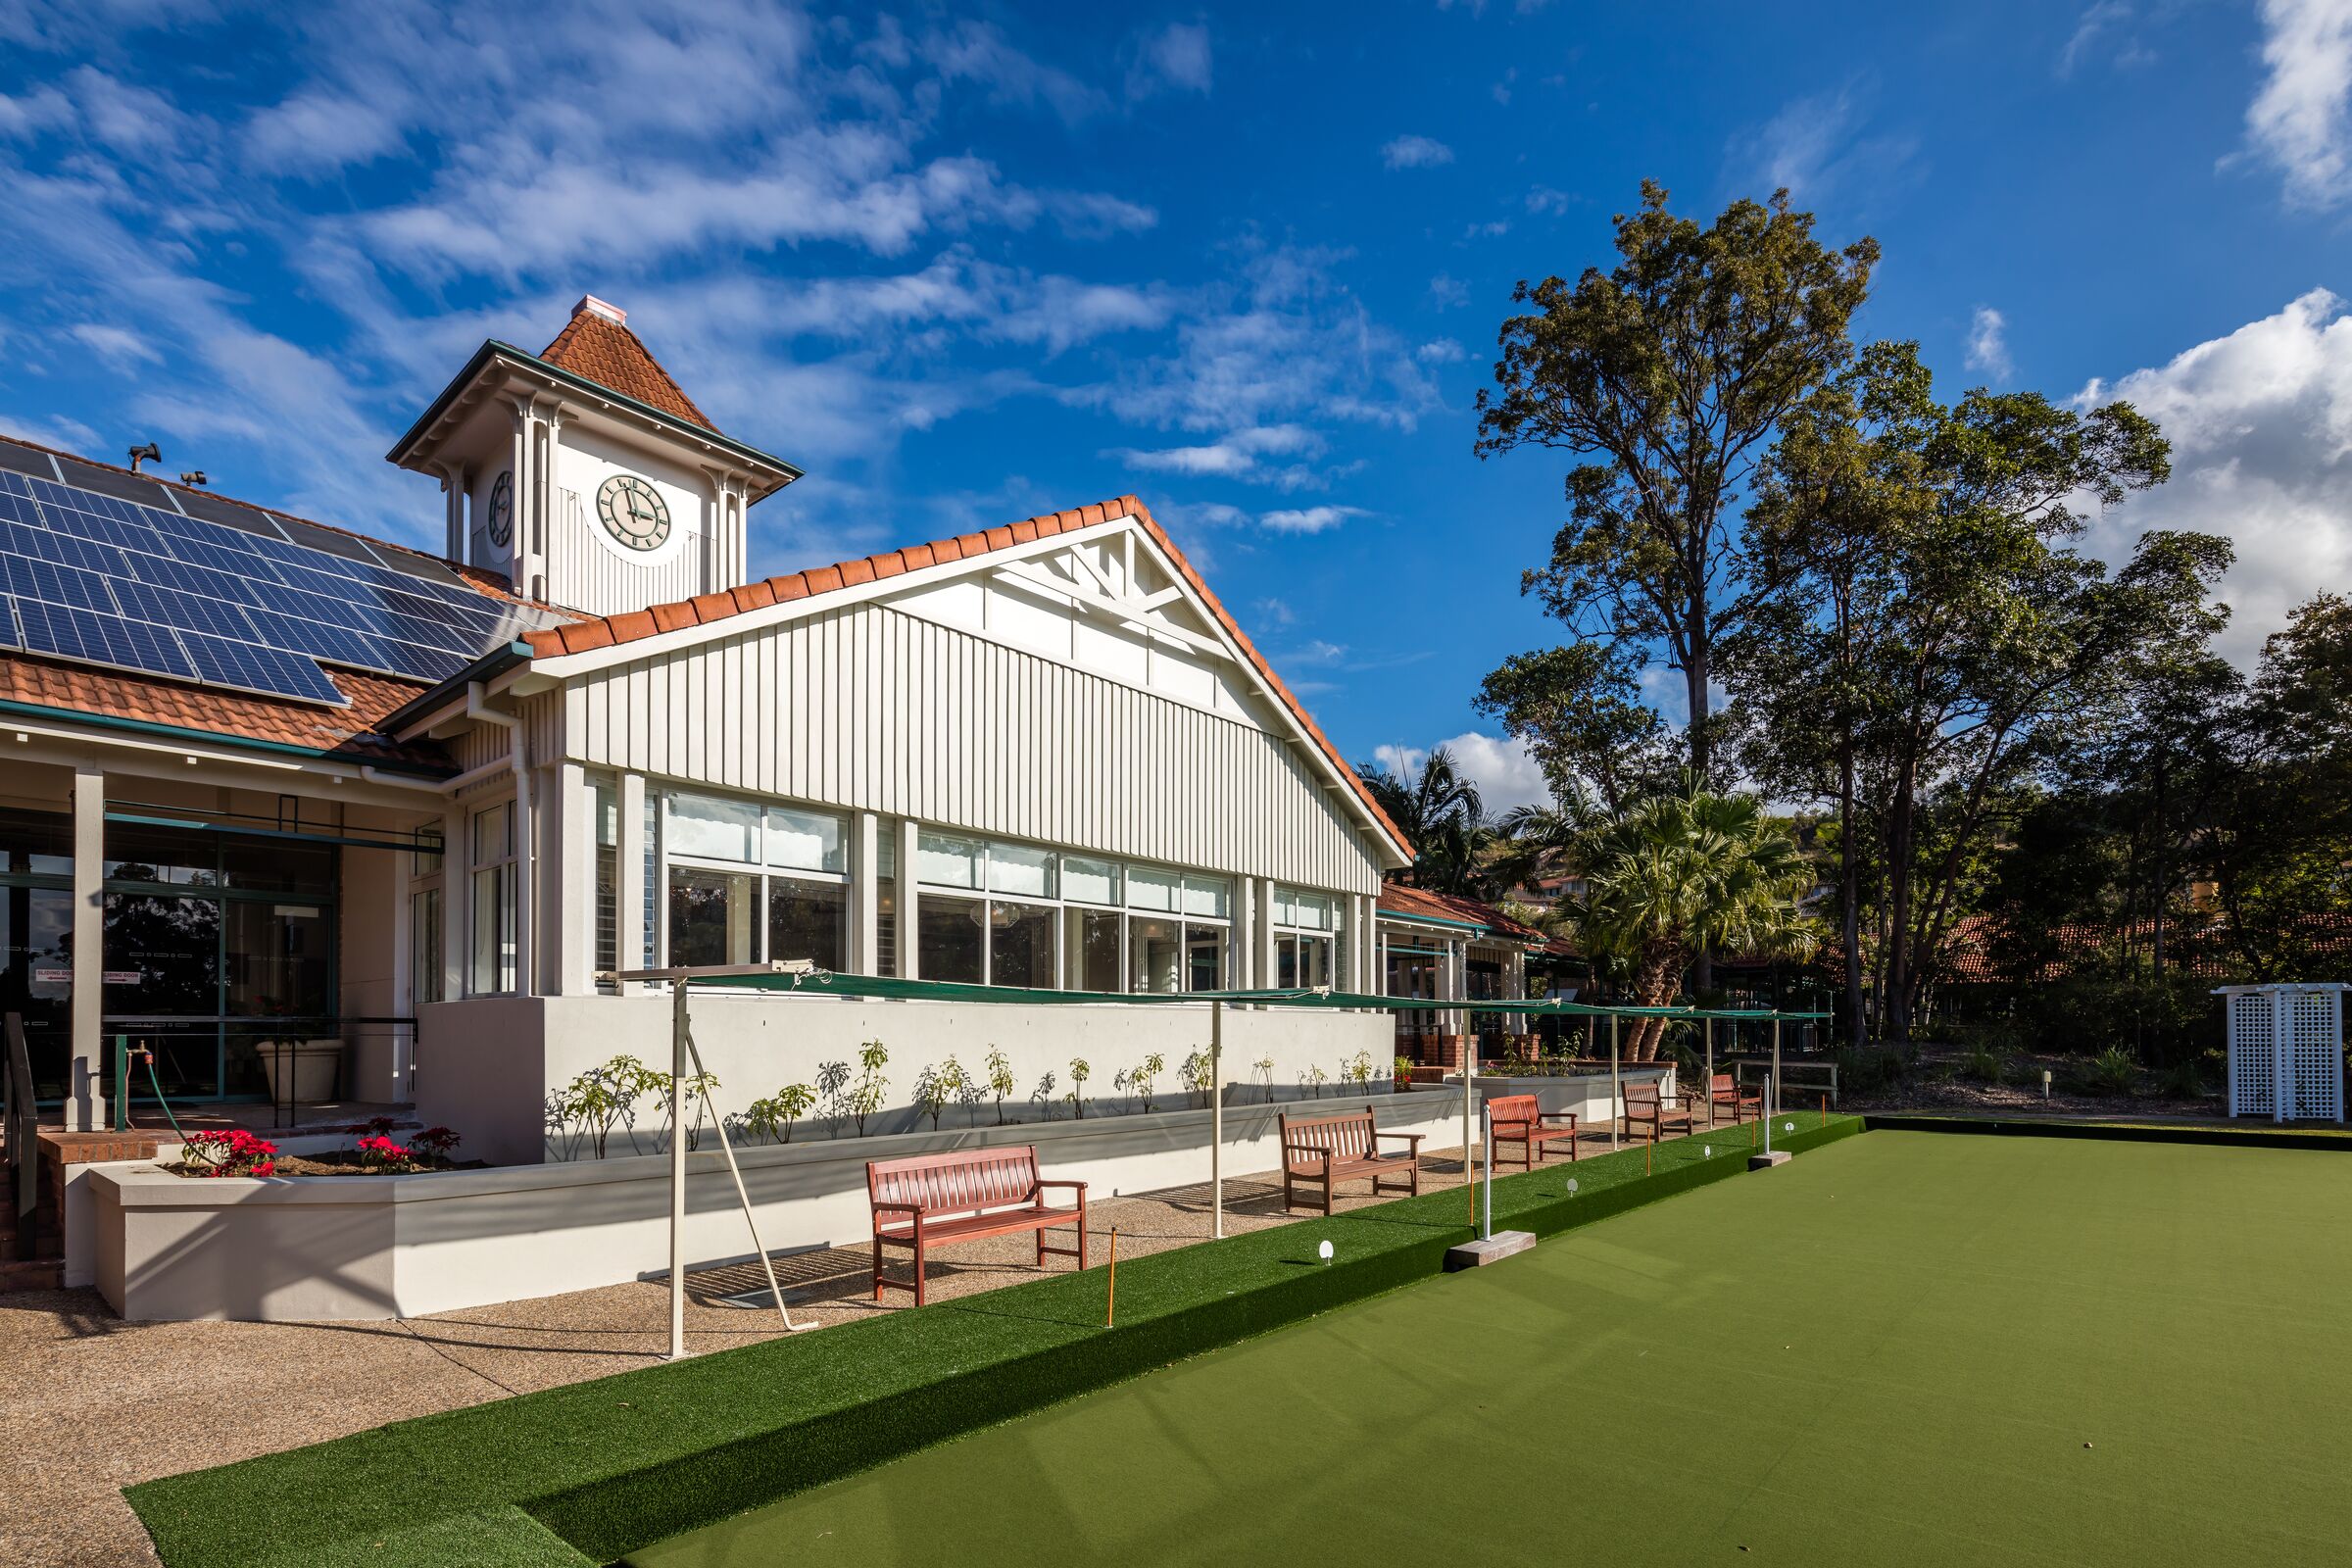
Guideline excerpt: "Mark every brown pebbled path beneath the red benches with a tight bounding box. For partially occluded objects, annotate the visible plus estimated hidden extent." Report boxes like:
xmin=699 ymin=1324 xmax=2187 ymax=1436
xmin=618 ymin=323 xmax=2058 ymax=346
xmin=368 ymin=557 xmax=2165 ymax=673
xmin=0 ymin=1138 xmax=1580 ymax=1568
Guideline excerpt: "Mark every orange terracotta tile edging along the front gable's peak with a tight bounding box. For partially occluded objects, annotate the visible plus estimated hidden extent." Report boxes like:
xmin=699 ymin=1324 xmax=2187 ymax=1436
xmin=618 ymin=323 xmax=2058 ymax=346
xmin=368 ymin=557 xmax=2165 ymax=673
xmin=527 ymin=496 xmax=1413 ymax=856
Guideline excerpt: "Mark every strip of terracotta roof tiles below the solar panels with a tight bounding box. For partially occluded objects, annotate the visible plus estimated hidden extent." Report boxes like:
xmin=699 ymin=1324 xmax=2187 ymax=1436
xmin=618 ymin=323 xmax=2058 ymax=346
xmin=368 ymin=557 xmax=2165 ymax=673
xmin=0 ymin=654 xmax=454 ymax=771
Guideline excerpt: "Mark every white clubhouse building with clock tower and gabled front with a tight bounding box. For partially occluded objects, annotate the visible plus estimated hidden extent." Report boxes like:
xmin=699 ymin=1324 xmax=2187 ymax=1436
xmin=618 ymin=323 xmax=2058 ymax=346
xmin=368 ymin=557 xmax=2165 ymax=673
xmin=0 ymin=299 xmax=1468 ymax=1161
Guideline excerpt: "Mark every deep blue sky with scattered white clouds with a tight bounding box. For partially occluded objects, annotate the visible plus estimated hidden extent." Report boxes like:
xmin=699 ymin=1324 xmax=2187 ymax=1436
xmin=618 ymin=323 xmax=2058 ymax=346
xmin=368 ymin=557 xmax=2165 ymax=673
xmin=0 ymin=0 xmax=2352 ymax=804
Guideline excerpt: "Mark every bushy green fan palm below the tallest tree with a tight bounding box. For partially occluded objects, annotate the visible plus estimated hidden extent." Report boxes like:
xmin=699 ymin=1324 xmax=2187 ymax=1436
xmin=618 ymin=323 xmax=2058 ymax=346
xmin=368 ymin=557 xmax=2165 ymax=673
xmin=1564 ymin=773 xmax=1818 ymax=1060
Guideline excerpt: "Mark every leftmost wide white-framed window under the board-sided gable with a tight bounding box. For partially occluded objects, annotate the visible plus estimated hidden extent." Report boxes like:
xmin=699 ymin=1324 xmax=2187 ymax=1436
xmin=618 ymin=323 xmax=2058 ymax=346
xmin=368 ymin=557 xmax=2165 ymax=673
xmin=661 ymin=795 xmax=849 ymax=968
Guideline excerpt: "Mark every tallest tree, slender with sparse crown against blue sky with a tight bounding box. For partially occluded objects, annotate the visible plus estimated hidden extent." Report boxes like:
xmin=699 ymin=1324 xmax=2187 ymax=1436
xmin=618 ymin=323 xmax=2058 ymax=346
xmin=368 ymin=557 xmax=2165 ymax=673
xmin=1477 ymin=181 xmax=1880 ymax=795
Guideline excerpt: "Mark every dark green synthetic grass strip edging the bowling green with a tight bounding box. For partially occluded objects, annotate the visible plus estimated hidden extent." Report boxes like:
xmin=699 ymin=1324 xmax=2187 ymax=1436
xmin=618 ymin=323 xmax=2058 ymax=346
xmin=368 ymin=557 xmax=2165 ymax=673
xmin=124 ymin=1114 xmax=1863 ymax=1568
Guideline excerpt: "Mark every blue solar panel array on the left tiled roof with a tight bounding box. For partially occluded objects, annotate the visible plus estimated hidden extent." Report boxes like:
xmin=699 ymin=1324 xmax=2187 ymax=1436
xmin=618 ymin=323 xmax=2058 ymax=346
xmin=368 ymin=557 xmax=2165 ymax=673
xmin=0 ymin=463 xmax=551 ymax=706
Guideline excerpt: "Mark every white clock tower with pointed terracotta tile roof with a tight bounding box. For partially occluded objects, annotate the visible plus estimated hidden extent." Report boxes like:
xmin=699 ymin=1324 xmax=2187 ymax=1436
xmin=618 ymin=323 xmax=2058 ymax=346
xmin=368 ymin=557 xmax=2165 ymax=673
xmin=388 ymin=294 xmax=800 ymax=615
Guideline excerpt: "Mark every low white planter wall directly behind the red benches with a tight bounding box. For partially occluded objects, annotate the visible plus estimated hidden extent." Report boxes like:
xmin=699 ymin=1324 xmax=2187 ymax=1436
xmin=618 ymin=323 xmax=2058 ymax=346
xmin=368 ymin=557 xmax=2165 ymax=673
xmin=87 ymin=1091 xmax=1467 ymax=1321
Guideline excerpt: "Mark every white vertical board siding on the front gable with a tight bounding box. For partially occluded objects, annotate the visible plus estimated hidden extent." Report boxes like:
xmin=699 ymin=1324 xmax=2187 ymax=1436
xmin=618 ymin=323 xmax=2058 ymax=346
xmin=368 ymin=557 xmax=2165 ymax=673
xmin=563 ymin=604 xmax=1381 ymax=894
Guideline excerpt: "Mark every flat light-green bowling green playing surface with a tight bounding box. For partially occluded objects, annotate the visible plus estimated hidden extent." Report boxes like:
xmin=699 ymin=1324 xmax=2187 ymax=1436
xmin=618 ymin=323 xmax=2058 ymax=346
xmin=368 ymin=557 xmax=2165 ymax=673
xmin=628 ymin=1131 xmax=2352 ymax=1568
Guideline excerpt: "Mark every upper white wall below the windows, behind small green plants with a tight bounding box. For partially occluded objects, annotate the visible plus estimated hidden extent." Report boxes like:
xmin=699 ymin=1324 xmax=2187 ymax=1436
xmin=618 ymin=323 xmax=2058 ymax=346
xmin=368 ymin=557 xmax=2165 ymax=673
xmin=416 ymin=990 xmax=1395 ymax=1166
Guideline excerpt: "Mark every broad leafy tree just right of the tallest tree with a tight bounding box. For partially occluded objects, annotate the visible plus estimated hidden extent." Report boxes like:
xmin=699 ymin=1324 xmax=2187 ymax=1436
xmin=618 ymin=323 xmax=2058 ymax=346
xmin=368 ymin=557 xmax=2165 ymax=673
xmin=1727 ymin=343 xmax=2191 ymax=1039
